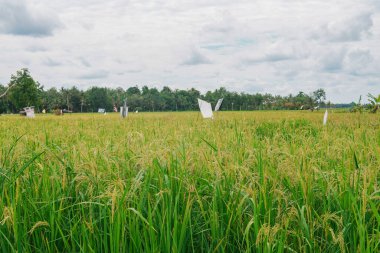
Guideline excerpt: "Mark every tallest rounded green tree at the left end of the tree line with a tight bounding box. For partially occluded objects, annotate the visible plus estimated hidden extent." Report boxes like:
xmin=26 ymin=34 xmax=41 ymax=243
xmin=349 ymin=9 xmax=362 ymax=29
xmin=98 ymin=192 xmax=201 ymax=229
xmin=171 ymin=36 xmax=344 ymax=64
xmin=9 ymin=68 xmax=43 ymax=111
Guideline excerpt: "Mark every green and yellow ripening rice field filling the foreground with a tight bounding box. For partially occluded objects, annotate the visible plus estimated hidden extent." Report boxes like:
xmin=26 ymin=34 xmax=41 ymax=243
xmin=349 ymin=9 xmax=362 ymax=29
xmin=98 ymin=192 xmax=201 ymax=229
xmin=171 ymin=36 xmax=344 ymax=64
xmin=0 ymin=111 xmax=380 ymax=252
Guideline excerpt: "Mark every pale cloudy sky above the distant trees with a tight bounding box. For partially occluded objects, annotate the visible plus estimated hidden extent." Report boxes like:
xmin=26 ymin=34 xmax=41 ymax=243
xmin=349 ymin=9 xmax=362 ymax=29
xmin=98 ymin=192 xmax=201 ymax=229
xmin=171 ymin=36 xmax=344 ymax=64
xmin=0 ymin=0 xmax=380 ymax=103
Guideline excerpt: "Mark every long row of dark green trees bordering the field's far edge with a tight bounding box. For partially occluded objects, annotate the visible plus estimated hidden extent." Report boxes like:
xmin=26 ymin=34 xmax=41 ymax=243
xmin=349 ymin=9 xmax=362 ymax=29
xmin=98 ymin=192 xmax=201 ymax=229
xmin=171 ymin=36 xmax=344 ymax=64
xmin=0 ymin=69 xmax=329 ymax=113
